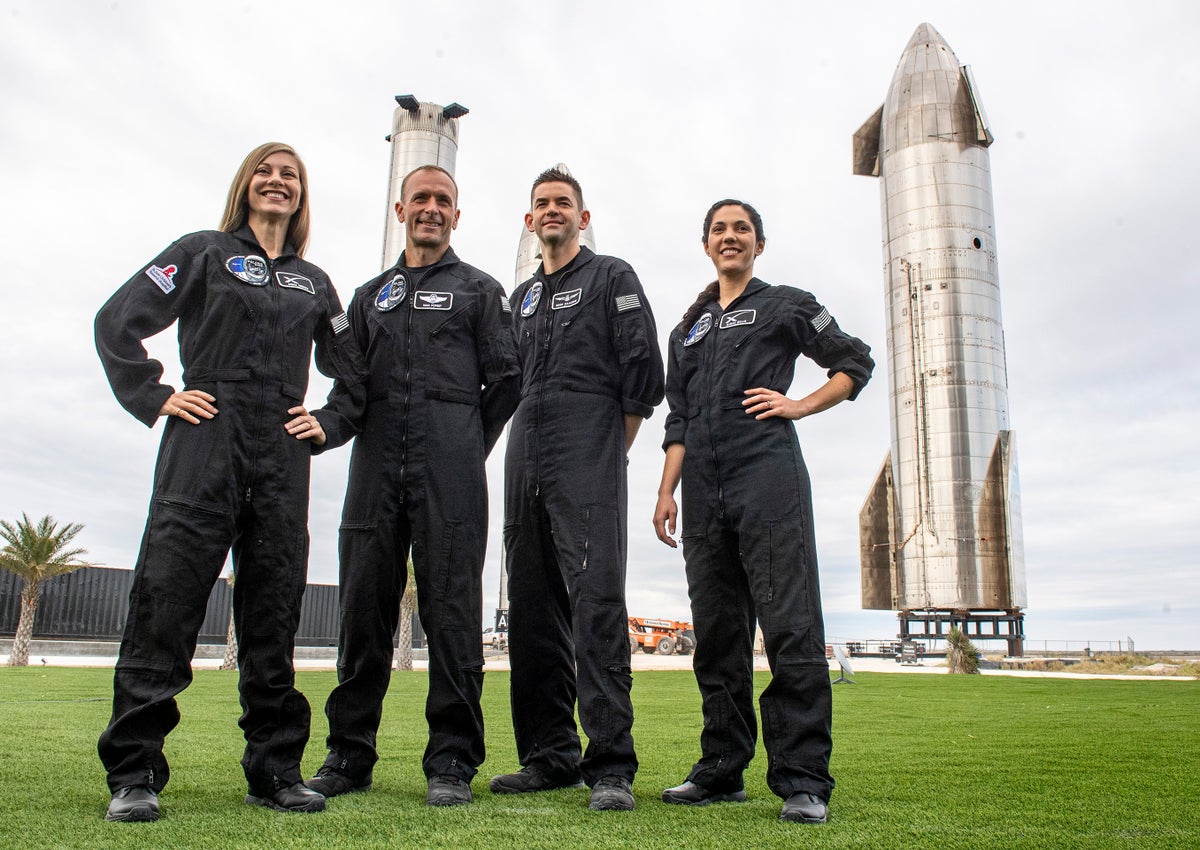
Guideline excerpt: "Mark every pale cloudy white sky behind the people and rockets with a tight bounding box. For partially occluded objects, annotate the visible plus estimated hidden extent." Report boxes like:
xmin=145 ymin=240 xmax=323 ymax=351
xmin=0 ymin=0 xmax=1200 ymax=648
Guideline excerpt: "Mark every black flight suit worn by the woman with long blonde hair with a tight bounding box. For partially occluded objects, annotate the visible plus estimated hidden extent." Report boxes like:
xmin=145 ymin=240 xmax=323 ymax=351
xmin=96 ymin=227 xmax=362 ymax=796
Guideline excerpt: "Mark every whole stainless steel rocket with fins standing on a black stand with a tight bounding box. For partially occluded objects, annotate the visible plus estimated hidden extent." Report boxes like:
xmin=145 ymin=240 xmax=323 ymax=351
xmin=853 ymin=24 xmax=1026 ymax=629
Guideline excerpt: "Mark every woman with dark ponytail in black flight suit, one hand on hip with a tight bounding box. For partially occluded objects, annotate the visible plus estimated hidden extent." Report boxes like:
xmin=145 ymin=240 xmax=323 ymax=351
xmin=654 ymin=199 xmax=875 ymax=824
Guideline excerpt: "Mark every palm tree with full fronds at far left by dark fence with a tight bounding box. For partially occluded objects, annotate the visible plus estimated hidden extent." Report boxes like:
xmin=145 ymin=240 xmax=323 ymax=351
xmin=0 ymin=514 xmax=91 ymax=668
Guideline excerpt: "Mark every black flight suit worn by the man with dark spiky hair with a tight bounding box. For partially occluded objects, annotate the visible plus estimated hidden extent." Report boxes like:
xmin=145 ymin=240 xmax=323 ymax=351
xmin=504 ymin=247 xmax=662 ymax=785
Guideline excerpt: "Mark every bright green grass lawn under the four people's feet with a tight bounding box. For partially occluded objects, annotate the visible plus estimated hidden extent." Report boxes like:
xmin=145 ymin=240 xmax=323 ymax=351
xmin=0 ymin=668 xmax=1200 ymax=850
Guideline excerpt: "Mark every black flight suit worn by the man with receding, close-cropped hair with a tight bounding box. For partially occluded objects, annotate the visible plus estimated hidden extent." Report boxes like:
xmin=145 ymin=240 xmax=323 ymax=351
xmin=316 ymin=249 xmax=521 ymax=783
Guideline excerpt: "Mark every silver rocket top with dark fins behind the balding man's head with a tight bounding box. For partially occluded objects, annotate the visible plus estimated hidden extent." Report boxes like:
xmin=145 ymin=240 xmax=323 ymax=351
xmin=380 ymin=95 xmax=467 ymax=269
